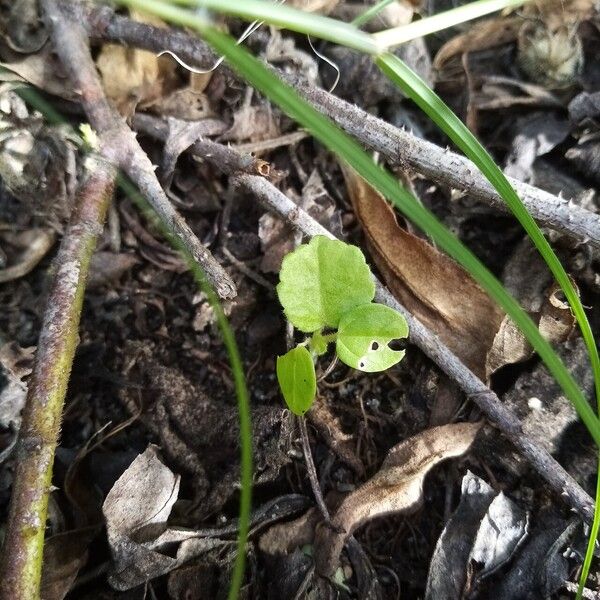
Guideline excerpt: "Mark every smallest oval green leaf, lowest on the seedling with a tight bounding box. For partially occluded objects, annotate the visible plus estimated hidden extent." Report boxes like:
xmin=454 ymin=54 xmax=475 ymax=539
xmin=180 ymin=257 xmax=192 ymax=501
xmin=277 ymin=346 xmax=317 ymax=415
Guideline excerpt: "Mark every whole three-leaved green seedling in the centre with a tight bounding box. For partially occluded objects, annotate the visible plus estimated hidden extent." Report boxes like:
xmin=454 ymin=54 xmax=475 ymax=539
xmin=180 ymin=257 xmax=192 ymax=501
xmin=277 ymin=235 xmax=408 ymax=415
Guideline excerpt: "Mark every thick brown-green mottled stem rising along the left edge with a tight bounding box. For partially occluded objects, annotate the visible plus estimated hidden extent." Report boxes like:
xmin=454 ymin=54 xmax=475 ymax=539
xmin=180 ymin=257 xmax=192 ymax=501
xmin=0 ymin=157 xmax=116 ymax=600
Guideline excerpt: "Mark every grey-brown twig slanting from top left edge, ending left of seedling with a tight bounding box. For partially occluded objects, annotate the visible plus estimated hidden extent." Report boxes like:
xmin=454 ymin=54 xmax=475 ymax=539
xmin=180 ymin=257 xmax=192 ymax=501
xmin=42 ymin=0 xmax=236 ymax=298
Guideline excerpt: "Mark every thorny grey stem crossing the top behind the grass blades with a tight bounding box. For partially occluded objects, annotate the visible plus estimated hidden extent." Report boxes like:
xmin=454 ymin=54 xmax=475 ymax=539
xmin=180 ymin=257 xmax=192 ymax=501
xmin=74 ymin=0 xmax=600 ymax=248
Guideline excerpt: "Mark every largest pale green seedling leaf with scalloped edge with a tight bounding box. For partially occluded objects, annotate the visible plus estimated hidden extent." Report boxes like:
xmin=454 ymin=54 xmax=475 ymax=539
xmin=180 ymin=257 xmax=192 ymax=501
xmin=277 ymin=235 xmax=375 ymax=332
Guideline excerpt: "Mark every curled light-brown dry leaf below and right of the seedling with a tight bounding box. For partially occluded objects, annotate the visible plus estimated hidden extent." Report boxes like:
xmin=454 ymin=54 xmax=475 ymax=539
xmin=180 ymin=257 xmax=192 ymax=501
xmin=315 ymin=423 xmax=481 ymax=576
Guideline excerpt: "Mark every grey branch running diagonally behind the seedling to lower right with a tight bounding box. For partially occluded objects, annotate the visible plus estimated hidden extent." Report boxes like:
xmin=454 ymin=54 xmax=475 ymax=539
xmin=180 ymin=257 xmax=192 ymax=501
xmin=134 ymin=116 xmax=594 ymax=521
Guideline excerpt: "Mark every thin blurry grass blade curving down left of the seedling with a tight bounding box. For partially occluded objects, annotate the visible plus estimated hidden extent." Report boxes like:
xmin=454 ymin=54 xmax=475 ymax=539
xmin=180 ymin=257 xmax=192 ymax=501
xmin=15 ymin=86 xmax=253 ymax=600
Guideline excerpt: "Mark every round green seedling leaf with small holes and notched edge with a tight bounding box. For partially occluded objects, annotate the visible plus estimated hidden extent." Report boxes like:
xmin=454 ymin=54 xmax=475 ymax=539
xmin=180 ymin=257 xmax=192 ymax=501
xmin=336 ymin=304 xmax=408 ymax=373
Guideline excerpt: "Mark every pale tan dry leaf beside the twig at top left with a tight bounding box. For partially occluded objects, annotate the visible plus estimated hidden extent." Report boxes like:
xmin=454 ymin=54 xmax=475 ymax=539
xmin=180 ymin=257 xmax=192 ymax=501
xmin=96 ymin=10 xmax=177 ymax=116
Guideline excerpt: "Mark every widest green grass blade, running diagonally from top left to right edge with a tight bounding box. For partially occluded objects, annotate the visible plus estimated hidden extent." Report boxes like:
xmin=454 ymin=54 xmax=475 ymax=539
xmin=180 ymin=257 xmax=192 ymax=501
xmin=115 ymin=0 xmax=600 ymax=445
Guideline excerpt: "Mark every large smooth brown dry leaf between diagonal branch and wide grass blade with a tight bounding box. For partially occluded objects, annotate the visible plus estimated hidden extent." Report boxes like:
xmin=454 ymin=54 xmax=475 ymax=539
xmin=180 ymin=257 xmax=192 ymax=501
xmin=344 ymin=168 xmax=504 ymax=377
